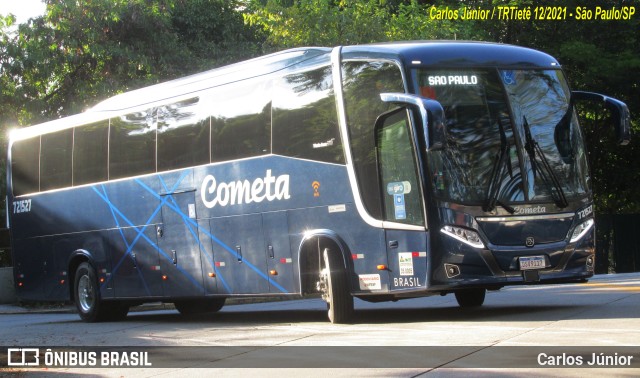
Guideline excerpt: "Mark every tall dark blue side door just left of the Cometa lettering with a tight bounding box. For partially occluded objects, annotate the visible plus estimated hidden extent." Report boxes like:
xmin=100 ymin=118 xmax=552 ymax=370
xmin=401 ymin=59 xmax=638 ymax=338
xmin=156 ymin=191 xmax=204 ymax=298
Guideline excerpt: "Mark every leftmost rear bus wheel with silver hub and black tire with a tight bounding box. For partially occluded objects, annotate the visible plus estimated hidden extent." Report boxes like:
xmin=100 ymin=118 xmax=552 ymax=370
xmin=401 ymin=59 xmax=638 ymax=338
xmin=73 ymin=262 xmax=129 ymax=323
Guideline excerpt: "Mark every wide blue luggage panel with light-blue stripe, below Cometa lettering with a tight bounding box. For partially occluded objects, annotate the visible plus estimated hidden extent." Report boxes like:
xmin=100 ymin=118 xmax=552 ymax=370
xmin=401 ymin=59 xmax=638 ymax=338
xmin=210 ymin=214 xmax=269 ymax=294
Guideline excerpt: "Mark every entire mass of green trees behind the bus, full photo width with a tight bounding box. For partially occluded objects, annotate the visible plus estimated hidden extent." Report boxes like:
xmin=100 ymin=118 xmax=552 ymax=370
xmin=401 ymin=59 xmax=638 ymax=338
xmin=0 ymin=0 xmax=640 ymax=213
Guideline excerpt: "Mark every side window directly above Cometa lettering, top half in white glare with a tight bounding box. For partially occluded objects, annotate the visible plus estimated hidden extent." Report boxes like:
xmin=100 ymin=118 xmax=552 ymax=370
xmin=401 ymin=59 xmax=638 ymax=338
xmin=210 ymin=80 xmax=271 ymax=162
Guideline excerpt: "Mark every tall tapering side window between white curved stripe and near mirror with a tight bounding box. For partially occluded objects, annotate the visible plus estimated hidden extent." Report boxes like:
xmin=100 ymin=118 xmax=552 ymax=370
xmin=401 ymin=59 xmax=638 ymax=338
xmin=342 ymin=61 xmax=404 ymax=219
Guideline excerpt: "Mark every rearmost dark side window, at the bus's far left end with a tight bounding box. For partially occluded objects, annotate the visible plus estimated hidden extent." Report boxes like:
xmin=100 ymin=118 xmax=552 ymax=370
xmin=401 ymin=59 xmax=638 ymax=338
xmin=11 ymin=137 xmax=40 ymax=196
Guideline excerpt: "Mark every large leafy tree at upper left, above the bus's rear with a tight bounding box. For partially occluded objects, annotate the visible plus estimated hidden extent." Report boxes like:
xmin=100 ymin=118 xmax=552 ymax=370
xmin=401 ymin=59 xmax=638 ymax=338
xmin=0 ymin=0 xmax=263 ymax=224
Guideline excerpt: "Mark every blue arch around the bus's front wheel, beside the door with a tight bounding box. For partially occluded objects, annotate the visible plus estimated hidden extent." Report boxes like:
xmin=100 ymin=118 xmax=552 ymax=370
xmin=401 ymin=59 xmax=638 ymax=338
xmin=298 ymin=229 xmax=354 ymax=295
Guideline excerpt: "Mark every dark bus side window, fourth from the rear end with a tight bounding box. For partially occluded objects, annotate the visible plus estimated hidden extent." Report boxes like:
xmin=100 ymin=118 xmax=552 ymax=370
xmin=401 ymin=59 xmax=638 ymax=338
xmin=109 ymin=110 xmax=156 ymax=180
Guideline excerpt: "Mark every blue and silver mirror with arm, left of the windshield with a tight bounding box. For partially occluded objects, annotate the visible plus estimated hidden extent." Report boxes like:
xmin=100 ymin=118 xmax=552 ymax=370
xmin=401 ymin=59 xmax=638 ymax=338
xmin=380 ymin=93 xmax=446 ymax=151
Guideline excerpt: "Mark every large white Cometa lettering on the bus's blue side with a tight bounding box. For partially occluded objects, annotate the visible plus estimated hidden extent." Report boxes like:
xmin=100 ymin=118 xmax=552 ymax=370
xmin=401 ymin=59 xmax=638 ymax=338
xmin=200 ymin=169 xmax=291 ymax=209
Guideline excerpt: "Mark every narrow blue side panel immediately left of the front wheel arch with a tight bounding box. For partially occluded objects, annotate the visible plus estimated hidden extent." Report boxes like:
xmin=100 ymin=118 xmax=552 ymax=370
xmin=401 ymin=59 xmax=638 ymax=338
xmin=262 ymin=211 xmax=298 ymax=293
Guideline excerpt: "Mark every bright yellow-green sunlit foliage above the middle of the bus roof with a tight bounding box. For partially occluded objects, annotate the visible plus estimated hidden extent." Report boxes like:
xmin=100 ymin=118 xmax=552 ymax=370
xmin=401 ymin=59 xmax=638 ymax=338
xmin=245 ymin=0 xmax=473 ymax=49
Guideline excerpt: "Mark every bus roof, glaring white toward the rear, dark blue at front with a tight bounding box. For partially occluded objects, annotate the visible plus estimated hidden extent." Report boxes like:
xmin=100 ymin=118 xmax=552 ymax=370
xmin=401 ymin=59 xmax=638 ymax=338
xmin=10 ymin=41 xmax=560 ymax=140
